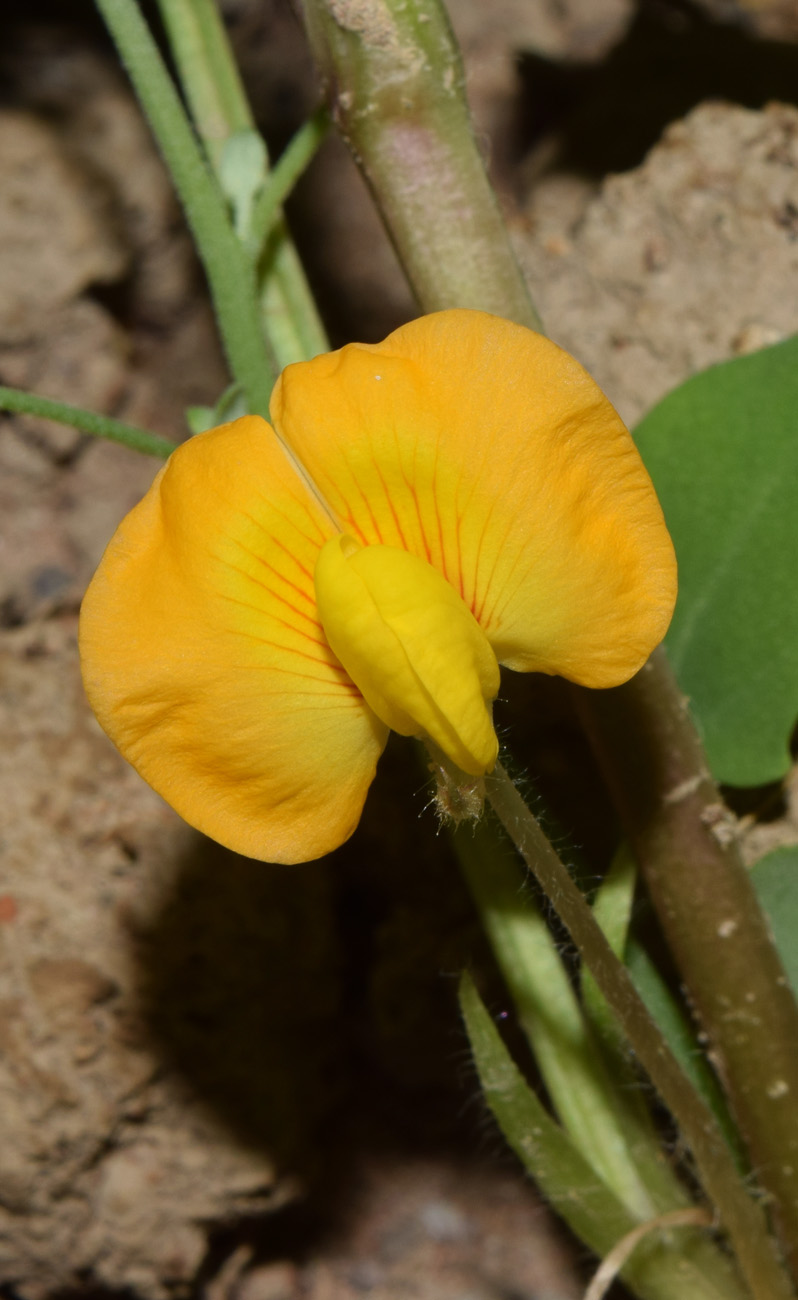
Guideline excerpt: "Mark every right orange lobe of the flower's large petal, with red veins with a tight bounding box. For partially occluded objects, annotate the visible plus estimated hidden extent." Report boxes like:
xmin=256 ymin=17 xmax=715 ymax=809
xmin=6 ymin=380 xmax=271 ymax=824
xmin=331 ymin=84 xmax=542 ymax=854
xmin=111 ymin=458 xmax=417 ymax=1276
xmin=272 ymin=311 xmax=676 ymax=686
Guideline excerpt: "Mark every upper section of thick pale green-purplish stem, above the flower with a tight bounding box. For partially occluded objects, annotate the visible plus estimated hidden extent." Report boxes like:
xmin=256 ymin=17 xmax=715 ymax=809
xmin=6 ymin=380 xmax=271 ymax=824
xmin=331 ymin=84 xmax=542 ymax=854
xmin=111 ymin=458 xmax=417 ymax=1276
xmin=303 ymin=0 xmax=541 ymax=329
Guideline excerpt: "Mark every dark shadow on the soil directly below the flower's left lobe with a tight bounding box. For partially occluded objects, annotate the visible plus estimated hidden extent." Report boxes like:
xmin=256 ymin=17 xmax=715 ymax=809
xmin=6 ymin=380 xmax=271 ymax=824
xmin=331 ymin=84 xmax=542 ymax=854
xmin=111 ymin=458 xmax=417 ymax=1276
xmin=135 ymin=744 xmax=512 ymax=1183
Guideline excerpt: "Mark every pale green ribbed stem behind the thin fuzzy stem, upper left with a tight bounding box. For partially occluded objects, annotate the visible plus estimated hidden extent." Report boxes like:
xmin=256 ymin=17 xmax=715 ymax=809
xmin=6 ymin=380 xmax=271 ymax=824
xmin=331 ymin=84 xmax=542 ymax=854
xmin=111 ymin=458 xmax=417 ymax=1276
xmin=159 ymin=0 xmax=330 ymax=371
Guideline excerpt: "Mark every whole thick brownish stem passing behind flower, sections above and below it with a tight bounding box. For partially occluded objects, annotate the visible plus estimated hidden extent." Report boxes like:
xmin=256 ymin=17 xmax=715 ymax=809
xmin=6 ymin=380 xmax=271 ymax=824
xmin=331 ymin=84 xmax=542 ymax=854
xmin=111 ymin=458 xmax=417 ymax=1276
xmin=304 ymin=0 xmax=798 ymax=1258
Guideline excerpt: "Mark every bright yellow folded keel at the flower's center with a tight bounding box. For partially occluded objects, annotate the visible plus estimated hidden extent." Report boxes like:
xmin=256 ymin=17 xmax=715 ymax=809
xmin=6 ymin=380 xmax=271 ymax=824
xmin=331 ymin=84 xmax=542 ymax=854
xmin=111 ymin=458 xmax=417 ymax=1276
xmin=315 ymin=534 xmax=499 ymax=776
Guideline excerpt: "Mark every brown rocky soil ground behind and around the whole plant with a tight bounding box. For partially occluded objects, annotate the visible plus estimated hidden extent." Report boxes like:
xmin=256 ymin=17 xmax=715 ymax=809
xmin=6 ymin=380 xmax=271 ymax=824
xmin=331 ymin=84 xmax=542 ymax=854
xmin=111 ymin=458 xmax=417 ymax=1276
xmin=0 ymin=0 xmax=798 ymax=1300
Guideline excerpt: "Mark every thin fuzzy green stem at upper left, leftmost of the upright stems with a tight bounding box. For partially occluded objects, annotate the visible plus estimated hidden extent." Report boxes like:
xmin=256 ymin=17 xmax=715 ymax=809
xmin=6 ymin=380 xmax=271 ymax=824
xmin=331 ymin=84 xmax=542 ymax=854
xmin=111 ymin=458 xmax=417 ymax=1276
xmin=97 ymin=0 xmax=276 ymax=416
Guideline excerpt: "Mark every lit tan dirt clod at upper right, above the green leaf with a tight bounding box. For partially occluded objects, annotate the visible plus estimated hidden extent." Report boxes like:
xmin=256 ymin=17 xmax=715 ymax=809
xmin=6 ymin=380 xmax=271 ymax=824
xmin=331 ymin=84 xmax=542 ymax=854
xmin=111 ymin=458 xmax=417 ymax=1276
xmin=516 ymin=103 xmax=798 ymax=424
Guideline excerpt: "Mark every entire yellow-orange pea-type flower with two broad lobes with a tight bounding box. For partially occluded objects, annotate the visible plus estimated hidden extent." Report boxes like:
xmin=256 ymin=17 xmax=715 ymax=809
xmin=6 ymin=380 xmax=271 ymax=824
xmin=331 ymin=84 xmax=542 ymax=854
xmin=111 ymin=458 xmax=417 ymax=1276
xmin=81 ymin=311 xmax=676 ymax=862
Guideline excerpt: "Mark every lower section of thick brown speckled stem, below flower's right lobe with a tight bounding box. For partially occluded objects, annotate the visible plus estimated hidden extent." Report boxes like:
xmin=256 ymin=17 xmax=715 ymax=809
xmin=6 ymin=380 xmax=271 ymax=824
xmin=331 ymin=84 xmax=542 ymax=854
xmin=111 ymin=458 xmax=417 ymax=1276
xmin=577 ymin=650 xmax=798 ymax=1269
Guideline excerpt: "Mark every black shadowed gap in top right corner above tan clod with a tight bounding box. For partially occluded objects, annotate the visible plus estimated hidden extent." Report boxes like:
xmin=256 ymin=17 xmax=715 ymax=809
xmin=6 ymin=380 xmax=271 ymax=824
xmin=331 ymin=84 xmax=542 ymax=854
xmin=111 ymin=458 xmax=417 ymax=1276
xmin=516 ymin=0 xmax=798 ymax=179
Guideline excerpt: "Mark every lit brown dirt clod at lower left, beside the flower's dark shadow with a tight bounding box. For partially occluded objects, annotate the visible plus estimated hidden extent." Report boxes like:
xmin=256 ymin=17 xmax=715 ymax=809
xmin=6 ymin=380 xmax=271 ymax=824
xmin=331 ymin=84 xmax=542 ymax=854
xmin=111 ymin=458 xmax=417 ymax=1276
xmin=0 ymin=618 xmax=291 ymax=1300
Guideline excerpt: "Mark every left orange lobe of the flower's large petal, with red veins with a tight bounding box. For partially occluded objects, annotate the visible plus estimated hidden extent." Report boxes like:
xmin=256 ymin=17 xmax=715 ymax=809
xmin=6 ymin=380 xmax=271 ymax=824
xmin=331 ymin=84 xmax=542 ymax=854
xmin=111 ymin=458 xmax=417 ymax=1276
xmin=81 ymin=416 xmax=387 ymax=862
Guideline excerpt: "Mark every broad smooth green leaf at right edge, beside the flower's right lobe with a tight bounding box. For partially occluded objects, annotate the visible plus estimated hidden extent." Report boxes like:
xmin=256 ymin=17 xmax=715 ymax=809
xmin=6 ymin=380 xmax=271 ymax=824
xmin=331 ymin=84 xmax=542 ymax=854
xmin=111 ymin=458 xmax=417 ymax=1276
xmin=636 ymin=338 xmax=798 ymax=785
